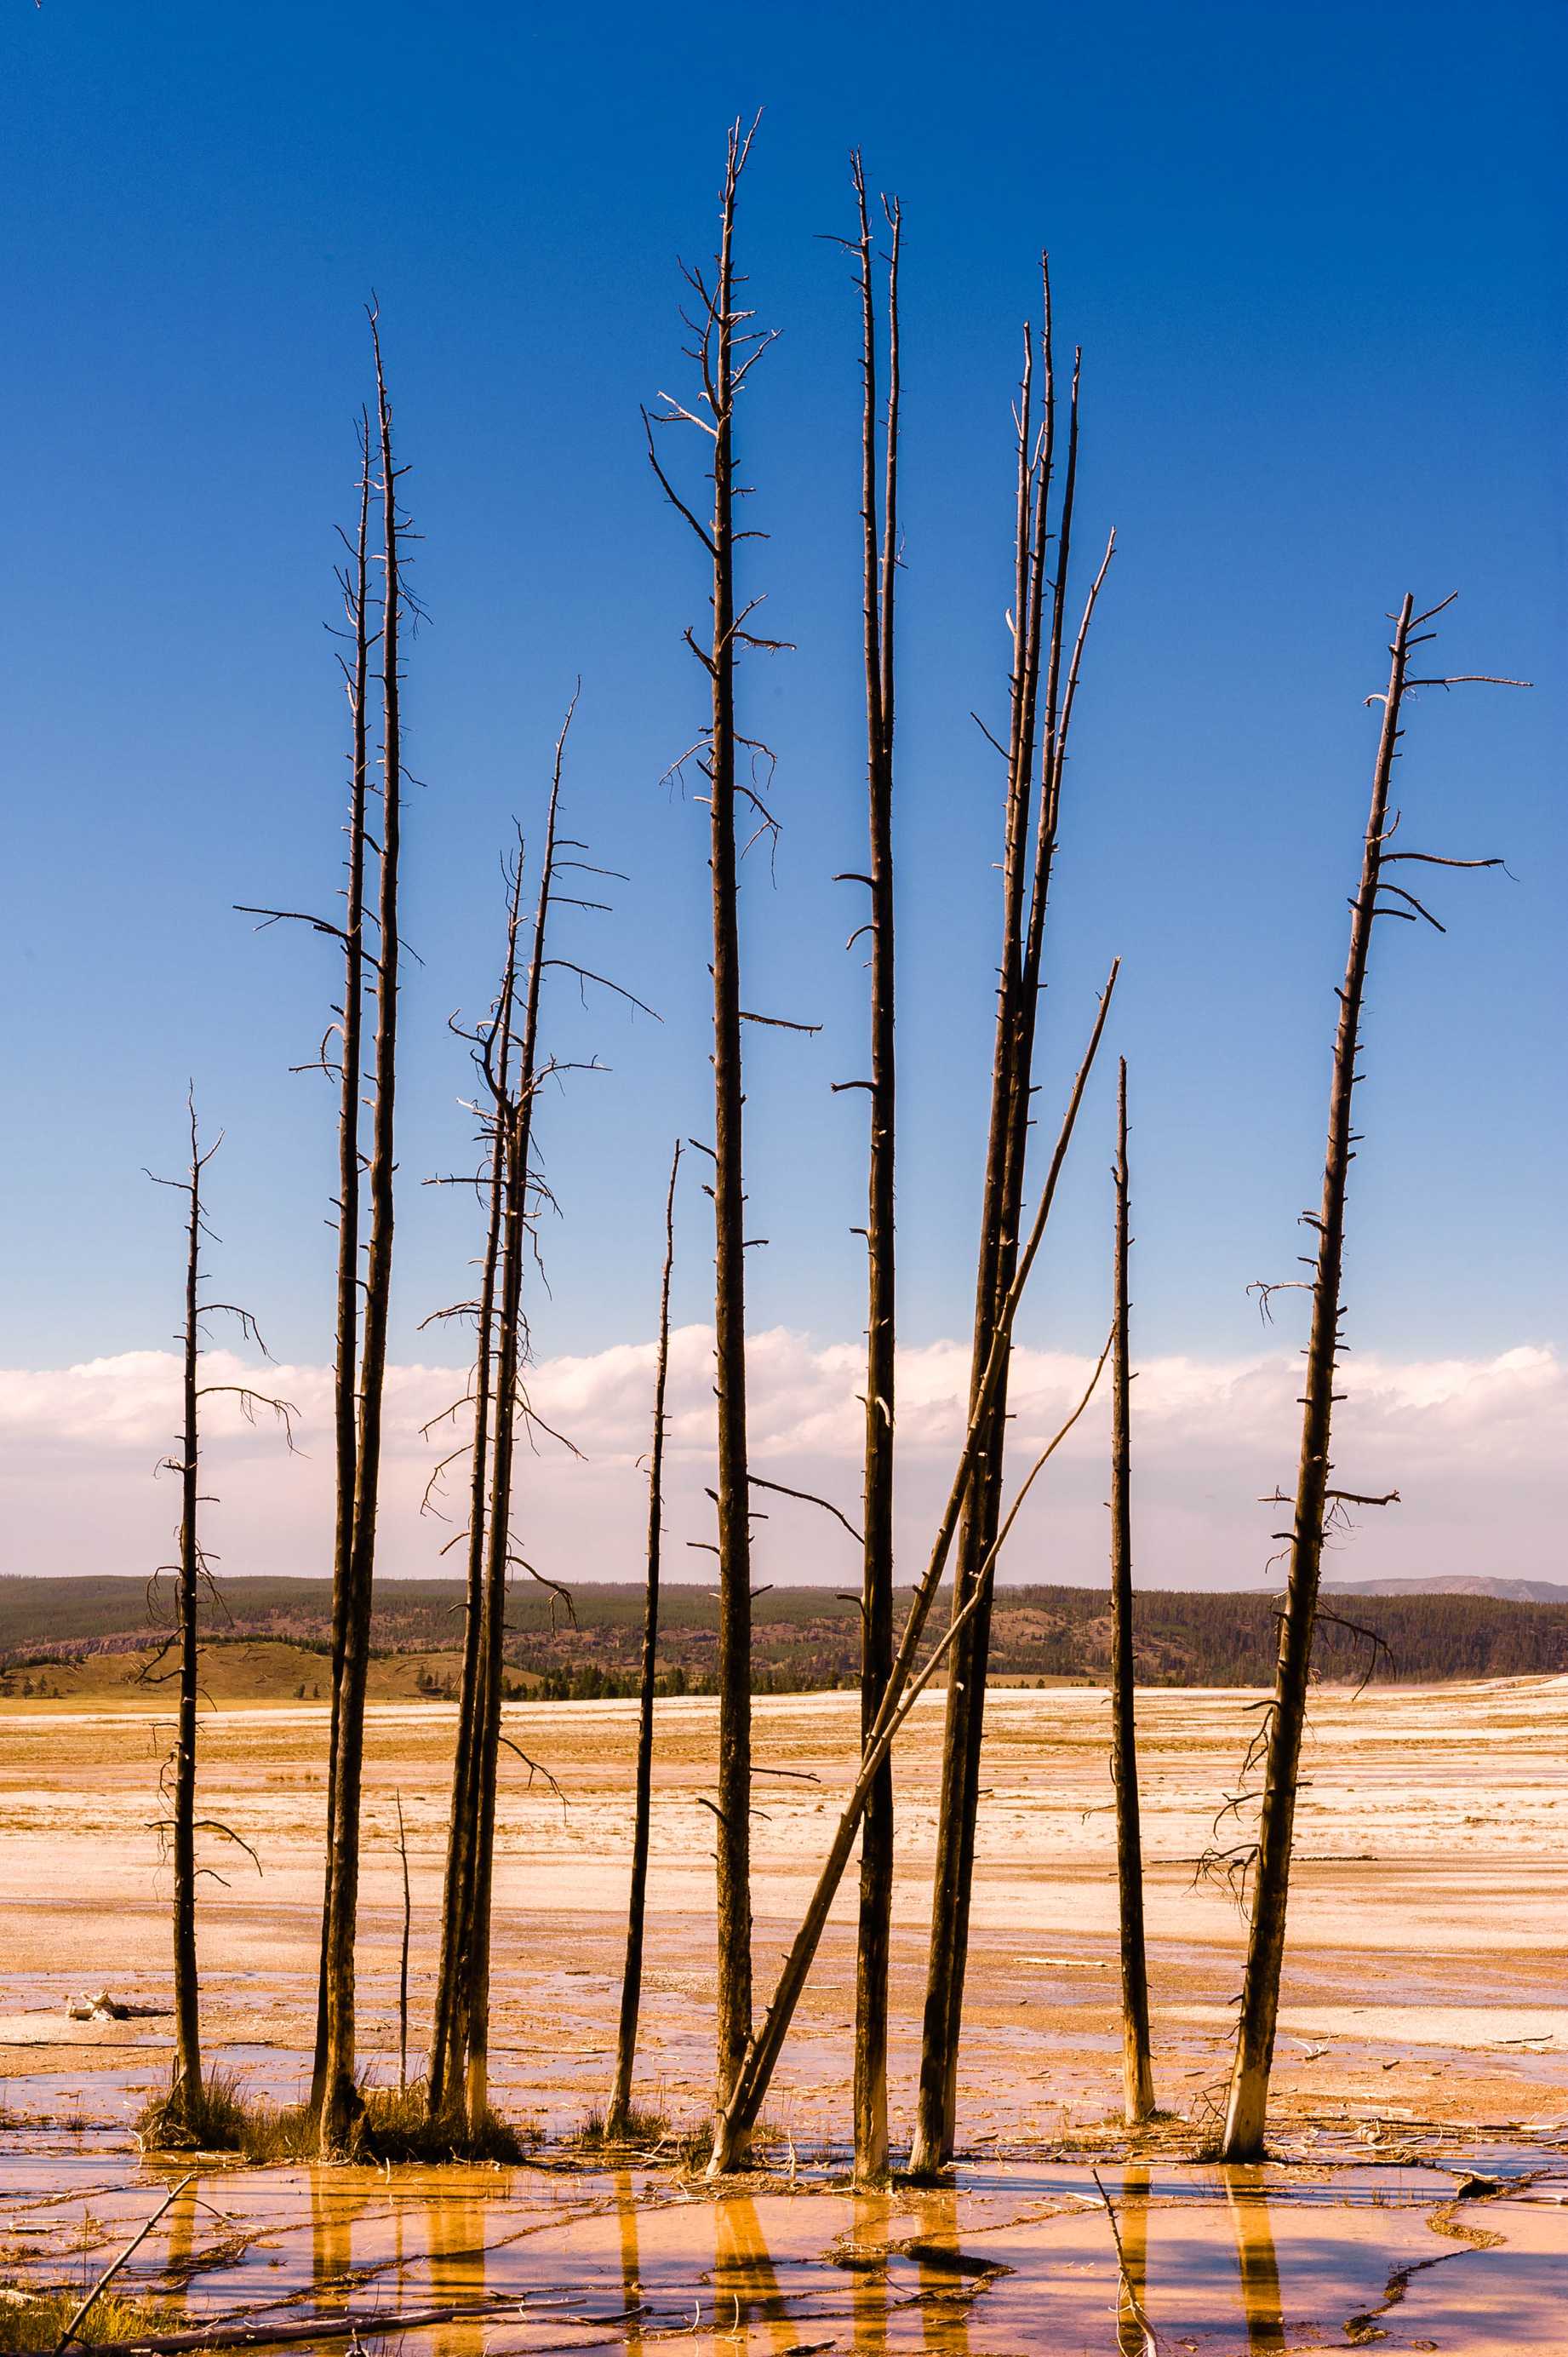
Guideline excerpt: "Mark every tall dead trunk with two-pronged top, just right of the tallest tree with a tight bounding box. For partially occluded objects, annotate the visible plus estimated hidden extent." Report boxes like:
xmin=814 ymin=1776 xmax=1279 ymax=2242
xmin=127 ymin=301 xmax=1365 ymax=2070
xmin=854 ymin=156 xmax=901 ymax=2182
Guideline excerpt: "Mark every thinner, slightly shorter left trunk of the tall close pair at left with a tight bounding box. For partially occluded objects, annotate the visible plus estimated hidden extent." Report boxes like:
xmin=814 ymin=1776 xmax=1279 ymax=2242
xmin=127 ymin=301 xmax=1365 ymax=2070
xmin=312 ymin=410 xmax=370 ymax=2112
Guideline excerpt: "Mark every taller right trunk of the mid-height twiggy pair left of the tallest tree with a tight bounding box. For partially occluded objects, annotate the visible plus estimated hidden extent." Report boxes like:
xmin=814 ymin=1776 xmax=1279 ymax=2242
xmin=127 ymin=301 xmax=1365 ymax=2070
xmin=462 ymin=716 xmax=564 ymax=2133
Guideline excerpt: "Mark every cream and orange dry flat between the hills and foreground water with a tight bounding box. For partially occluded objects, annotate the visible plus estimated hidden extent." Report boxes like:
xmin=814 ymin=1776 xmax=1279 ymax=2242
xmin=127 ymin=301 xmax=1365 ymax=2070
xmin=0 ymin=1678 xmax=1568 ymax=2145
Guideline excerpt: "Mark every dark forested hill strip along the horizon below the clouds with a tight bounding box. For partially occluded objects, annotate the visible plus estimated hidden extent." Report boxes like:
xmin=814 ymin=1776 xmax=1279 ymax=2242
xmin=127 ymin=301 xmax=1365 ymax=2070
xmin=0 ymin=1577 xmax=1568 ymax=1695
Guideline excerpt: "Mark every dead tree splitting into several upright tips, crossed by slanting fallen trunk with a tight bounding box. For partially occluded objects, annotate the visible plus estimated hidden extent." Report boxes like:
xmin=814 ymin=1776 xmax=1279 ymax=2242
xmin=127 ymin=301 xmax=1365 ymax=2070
xmin=910 ymin=271 xmax=1115 ymax=2176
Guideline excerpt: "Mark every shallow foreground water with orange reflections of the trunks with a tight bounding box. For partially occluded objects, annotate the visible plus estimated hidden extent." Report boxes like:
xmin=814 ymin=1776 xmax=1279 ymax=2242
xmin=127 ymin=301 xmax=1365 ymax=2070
xmin=0 ymin=2159 xmax=1568 ymax=2357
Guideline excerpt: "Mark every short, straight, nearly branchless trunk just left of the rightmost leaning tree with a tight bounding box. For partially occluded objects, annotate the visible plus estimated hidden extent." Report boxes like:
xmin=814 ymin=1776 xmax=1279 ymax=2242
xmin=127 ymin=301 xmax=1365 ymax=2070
xmin=1111 ymin=1056 xmax=1155 ymax=2129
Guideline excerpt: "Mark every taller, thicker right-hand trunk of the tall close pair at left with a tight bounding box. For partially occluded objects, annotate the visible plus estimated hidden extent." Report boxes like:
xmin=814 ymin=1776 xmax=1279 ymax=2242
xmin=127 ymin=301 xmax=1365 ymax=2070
xmin=321 ymin=318 xmax=403 ymax=2154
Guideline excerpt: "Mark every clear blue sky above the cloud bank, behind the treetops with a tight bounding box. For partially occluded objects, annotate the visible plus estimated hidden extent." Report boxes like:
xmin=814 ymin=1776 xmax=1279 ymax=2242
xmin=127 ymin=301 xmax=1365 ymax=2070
xmin=0 ymin=0 xmax=1568 ymax=1395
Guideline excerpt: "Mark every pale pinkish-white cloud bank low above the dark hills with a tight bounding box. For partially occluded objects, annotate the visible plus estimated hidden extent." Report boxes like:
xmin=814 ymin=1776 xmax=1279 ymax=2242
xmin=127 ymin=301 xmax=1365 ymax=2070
xmin=0 ymin=1325 xmax=1568 ymax=1586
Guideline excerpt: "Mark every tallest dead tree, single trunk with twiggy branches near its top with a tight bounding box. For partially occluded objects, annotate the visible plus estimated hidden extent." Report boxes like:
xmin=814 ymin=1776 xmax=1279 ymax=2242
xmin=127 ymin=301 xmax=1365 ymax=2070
xmin=644 ymin=123 xmax=783 ymax=2140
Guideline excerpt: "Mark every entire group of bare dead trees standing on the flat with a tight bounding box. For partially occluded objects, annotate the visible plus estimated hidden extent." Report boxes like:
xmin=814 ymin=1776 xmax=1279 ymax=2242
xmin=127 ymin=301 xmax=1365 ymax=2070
xmin=146 ymin=125 xmax=1518 ymax=2182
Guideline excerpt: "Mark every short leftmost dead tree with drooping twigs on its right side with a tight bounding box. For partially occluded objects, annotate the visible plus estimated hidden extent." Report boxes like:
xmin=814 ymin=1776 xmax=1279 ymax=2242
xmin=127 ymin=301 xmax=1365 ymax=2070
xmin=144 ymin=1092 xmax=297 ymax=2136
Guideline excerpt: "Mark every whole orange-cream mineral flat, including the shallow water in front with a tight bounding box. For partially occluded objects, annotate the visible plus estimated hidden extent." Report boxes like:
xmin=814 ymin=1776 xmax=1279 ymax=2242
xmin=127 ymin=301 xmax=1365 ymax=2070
xmin=0 ymin=1681 xmax=1568 ymax=2357
